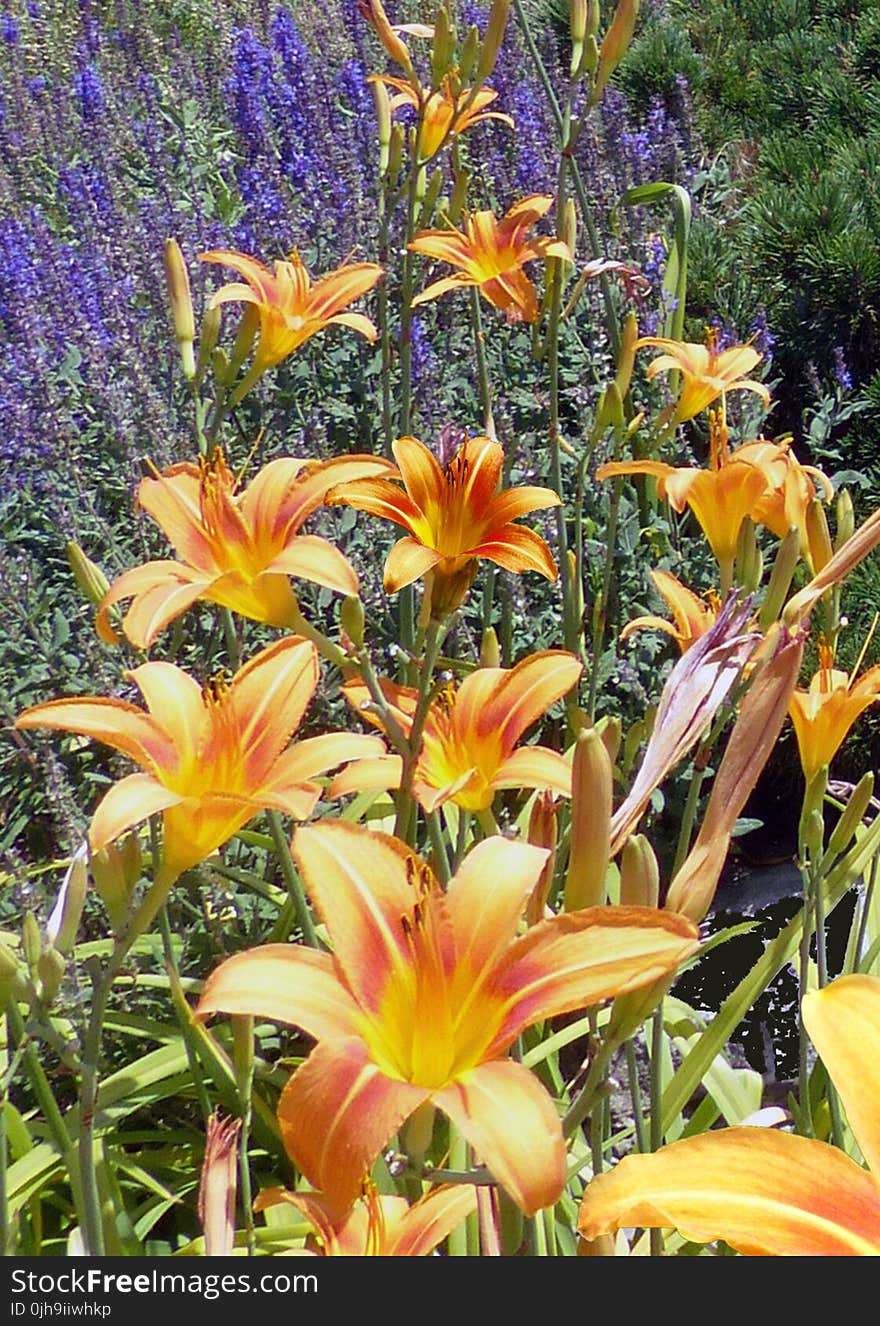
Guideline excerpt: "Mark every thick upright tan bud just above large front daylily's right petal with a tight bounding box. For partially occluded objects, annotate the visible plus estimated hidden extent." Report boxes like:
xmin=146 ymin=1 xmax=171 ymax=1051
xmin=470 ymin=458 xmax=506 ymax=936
xmin=565 ymin=728 xmax=614 ymax=911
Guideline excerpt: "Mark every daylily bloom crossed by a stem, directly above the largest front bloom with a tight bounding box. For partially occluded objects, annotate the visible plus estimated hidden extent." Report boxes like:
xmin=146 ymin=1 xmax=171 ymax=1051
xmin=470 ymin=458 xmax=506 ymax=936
xmin=329 ymin=650 xmax=582 ymax=812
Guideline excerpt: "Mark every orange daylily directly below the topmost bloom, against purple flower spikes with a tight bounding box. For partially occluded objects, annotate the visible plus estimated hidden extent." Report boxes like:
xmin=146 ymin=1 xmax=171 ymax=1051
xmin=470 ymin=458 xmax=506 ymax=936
xmin=408 ymin=194 xmax=574 ymax=322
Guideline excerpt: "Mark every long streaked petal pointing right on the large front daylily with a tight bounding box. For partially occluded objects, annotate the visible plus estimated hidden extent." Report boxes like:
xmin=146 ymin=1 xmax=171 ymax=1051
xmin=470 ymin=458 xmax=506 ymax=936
xmin=486 ymin=907 xmax=698 ymax=1054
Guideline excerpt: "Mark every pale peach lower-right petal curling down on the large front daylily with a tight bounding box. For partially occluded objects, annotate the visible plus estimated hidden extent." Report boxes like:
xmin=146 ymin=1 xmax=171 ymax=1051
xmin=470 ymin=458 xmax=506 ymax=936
xmin=433 ymin=1059 xmax=566 ymax=1216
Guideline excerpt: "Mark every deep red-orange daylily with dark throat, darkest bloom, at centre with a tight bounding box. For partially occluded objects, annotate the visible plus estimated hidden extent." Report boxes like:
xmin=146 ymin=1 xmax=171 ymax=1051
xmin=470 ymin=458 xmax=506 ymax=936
xmin=326 ymin=438 xmax=561 ymax=617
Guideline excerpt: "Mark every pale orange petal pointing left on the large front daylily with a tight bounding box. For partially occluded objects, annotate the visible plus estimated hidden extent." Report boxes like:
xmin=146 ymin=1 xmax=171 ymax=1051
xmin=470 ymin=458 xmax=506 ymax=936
xmin=196 ymin=944 xmax=358 ymax=1038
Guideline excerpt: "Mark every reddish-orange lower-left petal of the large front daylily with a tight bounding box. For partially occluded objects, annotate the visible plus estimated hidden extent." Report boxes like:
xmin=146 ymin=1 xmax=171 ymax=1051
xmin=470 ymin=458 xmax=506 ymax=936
xmin=278 ymin=1034 xmax=431 ymax=1208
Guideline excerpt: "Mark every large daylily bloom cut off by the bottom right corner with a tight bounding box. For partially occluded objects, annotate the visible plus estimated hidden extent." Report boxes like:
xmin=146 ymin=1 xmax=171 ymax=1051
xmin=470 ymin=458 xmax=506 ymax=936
xmin=579 ymin=976 xmax=880 ymax=1257
